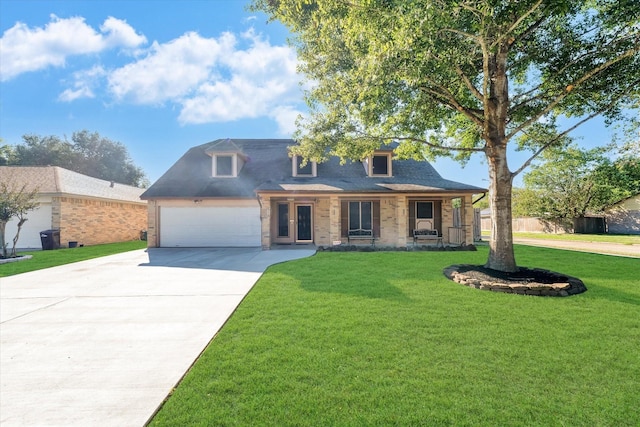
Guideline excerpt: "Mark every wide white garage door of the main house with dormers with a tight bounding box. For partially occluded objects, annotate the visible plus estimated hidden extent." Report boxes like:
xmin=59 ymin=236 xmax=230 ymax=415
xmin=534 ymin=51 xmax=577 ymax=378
xmin=160 ymin=207 xmax=261 ymax=248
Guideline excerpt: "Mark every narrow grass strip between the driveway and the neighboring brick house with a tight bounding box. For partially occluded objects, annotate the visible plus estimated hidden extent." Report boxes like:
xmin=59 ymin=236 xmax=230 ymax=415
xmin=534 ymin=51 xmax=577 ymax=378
xmin=0 ymin=240 xmax=147 ymax=277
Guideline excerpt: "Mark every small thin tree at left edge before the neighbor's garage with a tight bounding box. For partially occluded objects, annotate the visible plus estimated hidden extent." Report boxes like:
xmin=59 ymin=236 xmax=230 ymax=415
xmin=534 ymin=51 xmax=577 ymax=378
xmin=0 ymin=182 xmax=39 ymax=258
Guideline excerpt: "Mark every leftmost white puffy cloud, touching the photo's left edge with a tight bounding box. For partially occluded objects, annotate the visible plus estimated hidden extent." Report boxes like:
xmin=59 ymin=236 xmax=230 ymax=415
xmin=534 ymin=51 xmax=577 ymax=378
xmin=0 ymin=15 xmax=146 ymax=81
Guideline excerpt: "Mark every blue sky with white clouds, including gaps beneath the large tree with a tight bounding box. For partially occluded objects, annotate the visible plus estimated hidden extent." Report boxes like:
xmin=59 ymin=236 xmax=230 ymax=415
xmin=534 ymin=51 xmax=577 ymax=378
xmin=0 ymin=0 xmax=610 ymax=187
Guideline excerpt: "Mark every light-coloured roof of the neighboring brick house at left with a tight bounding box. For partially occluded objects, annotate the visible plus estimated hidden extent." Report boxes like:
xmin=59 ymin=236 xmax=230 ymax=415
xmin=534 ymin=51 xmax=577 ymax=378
xmin=0 ymin=166 xmax=145 ymax=203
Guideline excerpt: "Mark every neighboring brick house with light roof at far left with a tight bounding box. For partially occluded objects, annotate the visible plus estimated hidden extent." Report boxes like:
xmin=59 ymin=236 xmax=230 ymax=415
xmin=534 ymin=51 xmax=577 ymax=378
xmin=0 ymin=166 xmax=147 ymax=249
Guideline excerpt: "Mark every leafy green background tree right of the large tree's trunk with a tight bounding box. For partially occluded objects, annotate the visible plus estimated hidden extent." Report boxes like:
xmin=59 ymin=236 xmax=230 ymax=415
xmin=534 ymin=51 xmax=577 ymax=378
xmin=514 ymin=145 xmax=640 ymax=224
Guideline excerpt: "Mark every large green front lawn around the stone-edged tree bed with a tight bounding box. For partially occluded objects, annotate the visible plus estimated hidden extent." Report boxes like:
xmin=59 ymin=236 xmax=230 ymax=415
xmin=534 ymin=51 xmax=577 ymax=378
xmin=151 ymin=246 xmax=640 ymax=426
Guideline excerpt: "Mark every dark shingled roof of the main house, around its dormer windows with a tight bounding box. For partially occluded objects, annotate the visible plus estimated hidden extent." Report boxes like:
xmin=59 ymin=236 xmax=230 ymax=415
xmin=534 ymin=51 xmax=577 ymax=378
xmin=141 ymin=139 xmax=486 ymax=199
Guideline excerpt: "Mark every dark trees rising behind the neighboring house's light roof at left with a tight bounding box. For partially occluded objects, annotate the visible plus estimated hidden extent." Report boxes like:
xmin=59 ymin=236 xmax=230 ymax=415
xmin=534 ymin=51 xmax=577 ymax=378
xmin=7 ymin=130 xmax=149 ymax=187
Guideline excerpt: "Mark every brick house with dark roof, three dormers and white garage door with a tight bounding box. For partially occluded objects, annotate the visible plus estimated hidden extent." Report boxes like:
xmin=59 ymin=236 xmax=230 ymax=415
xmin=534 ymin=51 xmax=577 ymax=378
xmin=141 ymin=139 xmax=486 ymax=249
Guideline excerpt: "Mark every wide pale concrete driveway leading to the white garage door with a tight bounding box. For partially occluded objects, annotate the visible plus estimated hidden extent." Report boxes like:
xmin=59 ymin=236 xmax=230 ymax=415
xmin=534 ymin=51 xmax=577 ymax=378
xmin=0 ymin=249 xmax=314 ymax=427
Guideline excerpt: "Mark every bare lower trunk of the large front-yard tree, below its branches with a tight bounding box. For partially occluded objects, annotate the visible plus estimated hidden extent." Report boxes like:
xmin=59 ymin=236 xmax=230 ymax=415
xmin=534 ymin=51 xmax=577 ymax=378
xmin=485 ymin=147 xmax=517 ymax=272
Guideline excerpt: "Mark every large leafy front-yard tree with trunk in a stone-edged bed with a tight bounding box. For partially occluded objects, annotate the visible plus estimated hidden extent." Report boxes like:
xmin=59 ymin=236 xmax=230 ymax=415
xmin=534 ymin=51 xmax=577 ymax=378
xmin=254 ymin=0 xmax=640 ymax=271
